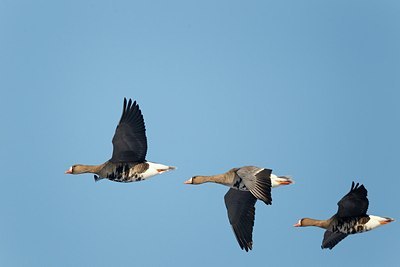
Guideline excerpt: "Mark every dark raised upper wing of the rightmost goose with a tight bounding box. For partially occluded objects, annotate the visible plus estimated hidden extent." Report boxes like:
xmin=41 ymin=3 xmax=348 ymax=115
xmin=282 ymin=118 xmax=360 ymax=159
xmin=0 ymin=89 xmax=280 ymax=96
xmin=337 ymin=182 xmax=369 ymax=218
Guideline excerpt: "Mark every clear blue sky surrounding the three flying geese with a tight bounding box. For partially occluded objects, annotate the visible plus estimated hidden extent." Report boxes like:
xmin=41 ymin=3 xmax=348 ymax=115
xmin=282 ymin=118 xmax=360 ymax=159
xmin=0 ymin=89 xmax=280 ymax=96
xmin=0 ymin=0 xmax=400 ymax=267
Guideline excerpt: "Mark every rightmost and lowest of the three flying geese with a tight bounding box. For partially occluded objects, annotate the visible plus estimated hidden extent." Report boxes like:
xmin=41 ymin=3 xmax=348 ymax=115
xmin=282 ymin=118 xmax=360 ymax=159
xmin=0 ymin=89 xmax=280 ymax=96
xmin=294 ymin=182 xmax=394 ymax=249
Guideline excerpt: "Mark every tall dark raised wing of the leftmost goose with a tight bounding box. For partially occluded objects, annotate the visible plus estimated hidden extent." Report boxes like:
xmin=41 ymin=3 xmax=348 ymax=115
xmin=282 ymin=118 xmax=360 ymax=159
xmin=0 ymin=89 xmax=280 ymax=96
xmin=110 ymin=98 xmax=147 ymax=162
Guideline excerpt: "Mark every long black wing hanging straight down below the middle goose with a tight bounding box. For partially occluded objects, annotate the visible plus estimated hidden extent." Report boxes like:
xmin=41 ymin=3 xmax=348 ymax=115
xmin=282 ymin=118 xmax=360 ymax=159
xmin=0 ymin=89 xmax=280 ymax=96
xmin=224 ymin=188 xmax=257 ymax=251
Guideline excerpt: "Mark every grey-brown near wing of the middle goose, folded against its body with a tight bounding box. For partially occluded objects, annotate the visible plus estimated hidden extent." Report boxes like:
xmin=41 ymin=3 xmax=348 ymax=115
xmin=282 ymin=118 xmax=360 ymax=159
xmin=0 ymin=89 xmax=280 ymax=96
xmin=236 ymin=166 xmax=272 ymax=205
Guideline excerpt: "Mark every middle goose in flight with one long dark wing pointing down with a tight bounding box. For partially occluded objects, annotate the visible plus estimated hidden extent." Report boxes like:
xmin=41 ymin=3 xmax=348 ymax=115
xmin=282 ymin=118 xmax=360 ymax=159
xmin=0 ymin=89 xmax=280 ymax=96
xmin=184 ymin=166 xmax=293 ymax=252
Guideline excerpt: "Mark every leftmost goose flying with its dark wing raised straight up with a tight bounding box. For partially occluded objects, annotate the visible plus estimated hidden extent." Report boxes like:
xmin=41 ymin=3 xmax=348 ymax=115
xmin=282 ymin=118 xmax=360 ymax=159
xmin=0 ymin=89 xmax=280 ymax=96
xmin=65 ymin=98 xmax=175 ymax=183
